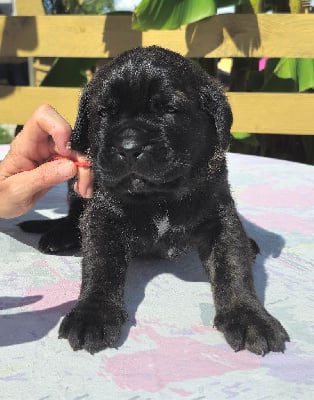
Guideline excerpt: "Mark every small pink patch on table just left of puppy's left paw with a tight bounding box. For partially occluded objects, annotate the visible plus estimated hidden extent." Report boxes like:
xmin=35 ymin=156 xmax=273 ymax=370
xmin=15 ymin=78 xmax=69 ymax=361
xmin=25 ymin=269 xmax=80 ymax=311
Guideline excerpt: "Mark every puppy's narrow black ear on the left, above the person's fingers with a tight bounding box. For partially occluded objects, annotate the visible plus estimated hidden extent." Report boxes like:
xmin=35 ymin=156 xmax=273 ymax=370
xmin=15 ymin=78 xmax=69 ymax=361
xmin=71 ymin=85 xmax=90 ymax=153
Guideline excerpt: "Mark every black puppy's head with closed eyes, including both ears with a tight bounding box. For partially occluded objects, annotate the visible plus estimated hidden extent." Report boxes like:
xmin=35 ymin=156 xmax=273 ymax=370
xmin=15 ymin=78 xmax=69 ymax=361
xmin=72 ymin=46 xmax=232 ymax=194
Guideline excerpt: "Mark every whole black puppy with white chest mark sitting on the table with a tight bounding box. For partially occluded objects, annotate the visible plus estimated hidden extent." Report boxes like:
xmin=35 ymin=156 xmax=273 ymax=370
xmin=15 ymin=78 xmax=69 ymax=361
xmin=22 ymin=47 xmax=289 ymax=355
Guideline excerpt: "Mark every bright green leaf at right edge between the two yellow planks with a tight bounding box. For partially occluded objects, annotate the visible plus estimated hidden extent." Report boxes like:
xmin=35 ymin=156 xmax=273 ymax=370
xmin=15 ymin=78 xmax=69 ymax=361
xmin=274 ymin=58 xmax=314 ymax=92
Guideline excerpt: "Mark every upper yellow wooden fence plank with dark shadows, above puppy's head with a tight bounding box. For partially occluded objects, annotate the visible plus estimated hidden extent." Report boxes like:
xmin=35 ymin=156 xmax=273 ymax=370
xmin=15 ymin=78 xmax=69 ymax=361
xmin=0 ymin=14 xmax=314 ymax=58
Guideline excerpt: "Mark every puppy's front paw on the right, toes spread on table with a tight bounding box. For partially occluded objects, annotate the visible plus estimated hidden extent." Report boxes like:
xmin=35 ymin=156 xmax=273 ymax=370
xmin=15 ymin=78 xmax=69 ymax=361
xmin=214 ymin=306 xmax=289 ymax=355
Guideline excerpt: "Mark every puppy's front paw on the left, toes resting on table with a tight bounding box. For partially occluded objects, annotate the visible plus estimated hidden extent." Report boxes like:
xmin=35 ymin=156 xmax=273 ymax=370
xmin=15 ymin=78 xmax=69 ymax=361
xmin=59 ymin=304 xmax=127 ymax=354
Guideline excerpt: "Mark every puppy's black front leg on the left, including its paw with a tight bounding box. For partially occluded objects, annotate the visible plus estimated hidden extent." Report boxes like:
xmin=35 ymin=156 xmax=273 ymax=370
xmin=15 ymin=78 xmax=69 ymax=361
xmin=59 ymin=207 xmax=129 ymax=354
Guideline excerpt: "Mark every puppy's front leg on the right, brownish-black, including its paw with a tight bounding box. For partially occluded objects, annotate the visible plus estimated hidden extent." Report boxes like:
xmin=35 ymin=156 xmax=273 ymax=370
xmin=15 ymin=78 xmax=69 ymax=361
xmin=200 ymin=204 xmax=289 ymax=355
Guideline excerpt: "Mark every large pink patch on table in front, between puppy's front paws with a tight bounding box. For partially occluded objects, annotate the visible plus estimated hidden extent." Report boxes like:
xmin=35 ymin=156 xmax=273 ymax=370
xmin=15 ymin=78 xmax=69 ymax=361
xmin=99 ymin=326 xmax=260 ymax=396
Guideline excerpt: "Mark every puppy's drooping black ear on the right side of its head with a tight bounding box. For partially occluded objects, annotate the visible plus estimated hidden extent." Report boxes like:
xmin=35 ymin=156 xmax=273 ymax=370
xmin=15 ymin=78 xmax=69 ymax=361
xmin=199 ymin=78 xmax=233 ymax=150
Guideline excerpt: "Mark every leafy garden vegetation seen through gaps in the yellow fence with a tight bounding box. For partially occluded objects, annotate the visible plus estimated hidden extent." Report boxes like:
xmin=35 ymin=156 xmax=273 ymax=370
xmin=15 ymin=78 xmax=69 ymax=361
xmin=0 ymin=0 xmax=314 ymax=164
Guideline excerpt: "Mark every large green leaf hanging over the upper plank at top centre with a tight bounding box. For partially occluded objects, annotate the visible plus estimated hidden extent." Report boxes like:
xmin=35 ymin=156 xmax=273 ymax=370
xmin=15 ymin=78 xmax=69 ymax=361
xmin=132 ymin=0 xmax=216 ymax=31
